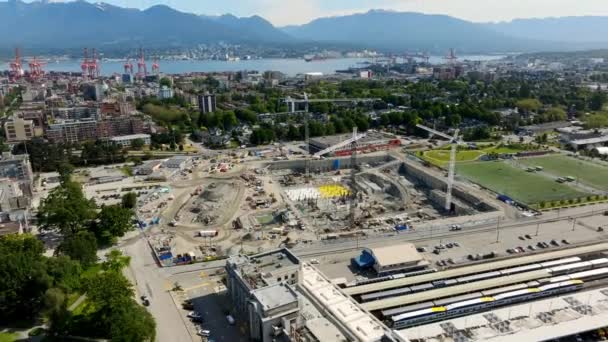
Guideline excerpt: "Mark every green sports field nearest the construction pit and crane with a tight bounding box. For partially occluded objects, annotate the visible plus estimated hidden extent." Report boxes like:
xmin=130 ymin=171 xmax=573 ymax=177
xmin=456 ymin=162 xmax=589 ymax=205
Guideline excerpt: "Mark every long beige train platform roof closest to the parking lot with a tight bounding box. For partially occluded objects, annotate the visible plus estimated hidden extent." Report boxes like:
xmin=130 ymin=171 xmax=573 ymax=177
xmin=343 ymin=243 xmax=608 ymax=296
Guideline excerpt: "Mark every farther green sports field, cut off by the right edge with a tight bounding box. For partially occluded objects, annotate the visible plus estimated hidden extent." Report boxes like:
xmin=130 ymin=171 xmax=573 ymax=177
xmin=520 ymin=154 xmax=608 ymax=190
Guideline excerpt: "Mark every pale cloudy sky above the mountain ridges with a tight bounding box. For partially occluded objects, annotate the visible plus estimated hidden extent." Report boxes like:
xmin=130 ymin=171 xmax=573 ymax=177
xmin=32 ymin=0 xmax=608 ymax=26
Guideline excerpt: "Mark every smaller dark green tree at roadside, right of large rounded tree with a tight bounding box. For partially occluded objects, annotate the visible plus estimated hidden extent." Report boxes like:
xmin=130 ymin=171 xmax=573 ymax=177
xmin=92 ymin=205 xmax=133 ymax=244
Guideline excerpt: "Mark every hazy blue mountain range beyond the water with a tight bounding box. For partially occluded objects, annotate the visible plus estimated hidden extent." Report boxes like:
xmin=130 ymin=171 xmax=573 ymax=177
xmin=0 ymin=0 xmax=608 ymax=53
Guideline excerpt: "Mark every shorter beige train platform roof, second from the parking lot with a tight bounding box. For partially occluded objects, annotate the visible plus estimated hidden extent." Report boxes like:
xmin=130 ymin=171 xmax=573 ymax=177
xmin=361 ymin=270 xmax=550 ymax=311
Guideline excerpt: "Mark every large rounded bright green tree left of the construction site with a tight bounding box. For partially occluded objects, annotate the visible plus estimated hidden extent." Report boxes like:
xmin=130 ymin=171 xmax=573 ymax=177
xmin=38 ymin=181 xmax=96 ymax=236
